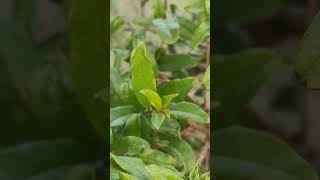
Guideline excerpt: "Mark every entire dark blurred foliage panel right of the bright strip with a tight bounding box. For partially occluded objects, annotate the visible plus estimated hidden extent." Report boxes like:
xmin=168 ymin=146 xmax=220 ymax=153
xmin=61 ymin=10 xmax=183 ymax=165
xmin=211 ymin=0 xmax=320 ymax=180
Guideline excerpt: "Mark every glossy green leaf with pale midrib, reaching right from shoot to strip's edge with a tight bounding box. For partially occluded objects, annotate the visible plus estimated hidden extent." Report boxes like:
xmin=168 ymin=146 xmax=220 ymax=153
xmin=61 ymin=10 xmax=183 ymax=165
xmin=170 ymin=101 xmax=210 ymax=123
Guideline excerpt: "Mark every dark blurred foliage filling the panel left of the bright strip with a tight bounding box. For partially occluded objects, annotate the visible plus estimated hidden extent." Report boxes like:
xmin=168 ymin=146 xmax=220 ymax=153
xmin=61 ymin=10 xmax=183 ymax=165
xmin=0 ymin=0 xmax=107 ymax=180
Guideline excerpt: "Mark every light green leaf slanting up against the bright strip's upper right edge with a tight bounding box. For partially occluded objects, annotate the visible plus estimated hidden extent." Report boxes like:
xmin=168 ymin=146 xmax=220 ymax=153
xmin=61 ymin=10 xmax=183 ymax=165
xmin=190 ymin=21 xmax=210 ymax=48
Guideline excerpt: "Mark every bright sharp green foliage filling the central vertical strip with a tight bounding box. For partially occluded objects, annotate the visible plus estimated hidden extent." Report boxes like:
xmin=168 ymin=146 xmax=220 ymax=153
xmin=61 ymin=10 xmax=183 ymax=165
xmin=110 ymin=0 xmax=210 ymax=180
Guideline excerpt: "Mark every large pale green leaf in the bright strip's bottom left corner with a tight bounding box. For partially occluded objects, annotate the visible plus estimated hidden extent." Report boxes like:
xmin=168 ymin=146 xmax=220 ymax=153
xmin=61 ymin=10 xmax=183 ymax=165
xmin=111 ymin=154 xmax=150 ymax=180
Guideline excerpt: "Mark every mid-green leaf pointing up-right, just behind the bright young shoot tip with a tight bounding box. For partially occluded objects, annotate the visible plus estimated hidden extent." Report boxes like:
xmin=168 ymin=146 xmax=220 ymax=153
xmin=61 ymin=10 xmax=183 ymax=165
xmin=158 ymin=77 xmax=196 ymax=102
